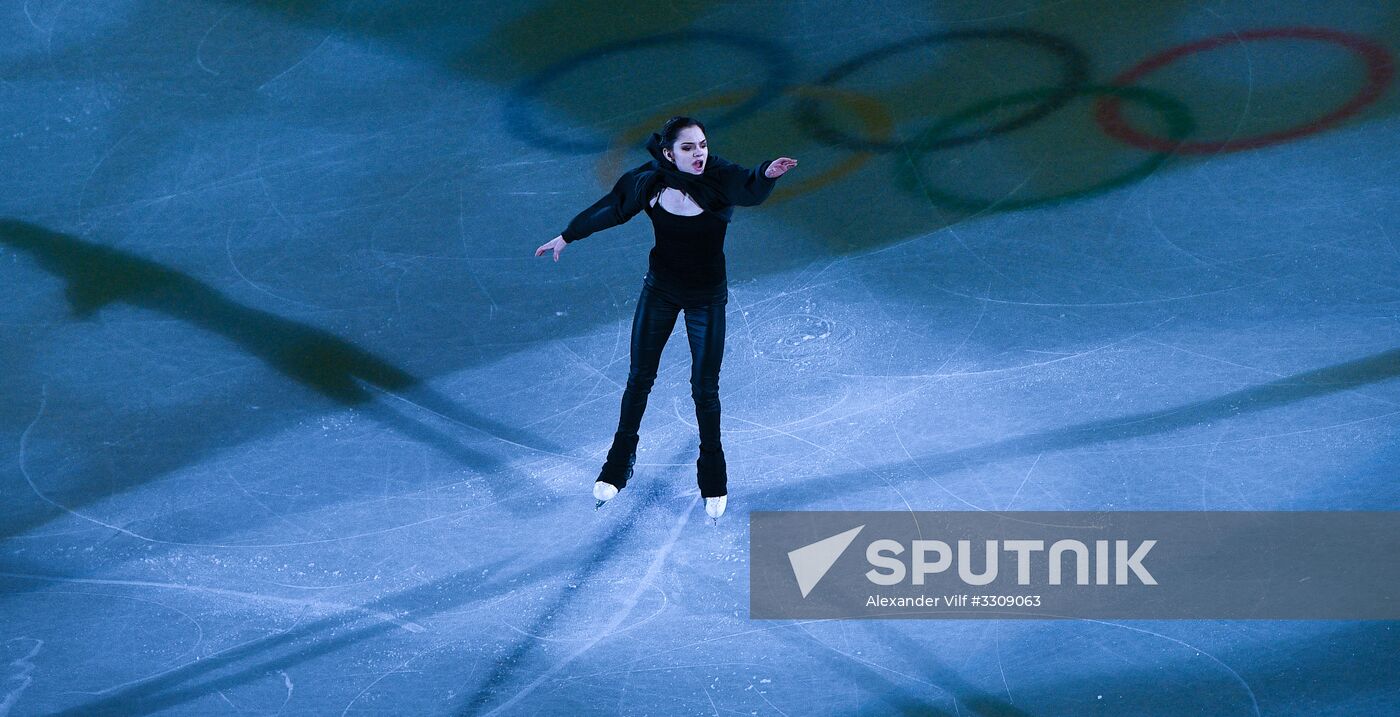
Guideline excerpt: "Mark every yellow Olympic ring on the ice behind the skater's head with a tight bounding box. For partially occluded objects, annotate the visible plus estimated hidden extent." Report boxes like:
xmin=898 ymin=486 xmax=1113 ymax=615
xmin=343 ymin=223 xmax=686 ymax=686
xmin=598 ymin=85 xmax=895 ymax=207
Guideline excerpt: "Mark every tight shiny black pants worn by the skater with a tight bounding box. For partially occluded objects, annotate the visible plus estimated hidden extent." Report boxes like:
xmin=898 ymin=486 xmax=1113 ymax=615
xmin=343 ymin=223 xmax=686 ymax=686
xmin=613 ymin=277 xmax=725 ymax=494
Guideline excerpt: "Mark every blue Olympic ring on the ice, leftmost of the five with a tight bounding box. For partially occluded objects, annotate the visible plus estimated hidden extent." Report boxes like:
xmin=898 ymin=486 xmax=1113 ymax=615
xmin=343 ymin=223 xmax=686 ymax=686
xmin=507 ymin=29 xmax=792 ymax=151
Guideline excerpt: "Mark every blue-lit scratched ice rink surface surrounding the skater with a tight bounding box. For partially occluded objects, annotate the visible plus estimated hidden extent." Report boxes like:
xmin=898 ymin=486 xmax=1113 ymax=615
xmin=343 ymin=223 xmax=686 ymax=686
xmin=0 ymin=0 xmax=1400 ymax=716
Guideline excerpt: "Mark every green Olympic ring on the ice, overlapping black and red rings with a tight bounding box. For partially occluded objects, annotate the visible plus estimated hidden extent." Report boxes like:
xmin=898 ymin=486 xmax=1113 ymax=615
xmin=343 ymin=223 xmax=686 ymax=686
xmin=895 ymin=85 xmax=1196 ymax=211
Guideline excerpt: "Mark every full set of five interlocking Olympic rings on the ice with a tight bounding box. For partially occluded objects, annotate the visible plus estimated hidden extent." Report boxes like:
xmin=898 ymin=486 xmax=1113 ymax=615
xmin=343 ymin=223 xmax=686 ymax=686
xmin=508 ymin=27 xmax=1394 ymax=211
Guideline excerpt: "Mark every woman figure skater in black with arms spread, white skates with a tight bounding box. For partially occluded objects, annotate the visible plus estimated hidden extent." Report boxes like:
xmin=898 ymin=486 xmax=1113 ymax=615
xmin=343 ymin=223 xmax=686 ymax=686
xmin=535 ymin=116 xmax=797 ymax=518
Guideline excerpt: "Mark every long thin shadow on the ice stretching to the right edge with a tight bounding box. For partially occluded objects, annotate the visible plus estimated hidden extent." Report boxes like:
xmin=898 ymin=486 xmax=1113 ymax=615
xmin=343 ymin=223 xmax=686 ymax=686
xmin=760 ymin=349 xmax=1400 ymax=510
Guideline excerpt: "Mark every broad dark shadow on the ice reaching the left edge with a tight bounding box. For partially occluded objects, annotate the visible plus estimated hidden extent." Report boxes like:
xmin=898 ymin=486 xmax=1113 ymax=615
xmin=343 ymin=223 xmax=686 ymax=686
xmin=0 ymin=220 xmax=559 ymax=535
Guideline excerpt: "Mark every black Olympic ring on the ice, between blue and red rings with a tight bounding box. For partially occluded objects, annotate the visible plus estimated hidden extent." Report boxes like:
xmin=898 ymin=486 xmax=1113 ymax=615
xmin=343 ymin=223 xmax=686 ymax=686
xmin=794 ymin=28 xmax=1089 ymax=151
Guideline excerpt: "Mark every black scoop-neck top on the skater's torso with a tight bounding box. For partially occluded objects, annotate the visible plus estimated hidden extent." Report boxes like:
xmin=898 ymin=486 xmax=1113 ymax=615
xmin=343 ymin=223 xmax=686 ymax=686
xmin=647 ymin=193 xmax=729 ymax=305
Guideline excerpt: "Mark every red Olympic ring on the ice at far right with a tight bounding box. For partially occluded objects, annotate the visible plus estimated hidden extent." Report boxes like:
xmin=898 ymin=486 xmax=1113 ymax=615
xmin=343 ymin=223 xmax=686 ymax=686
xmin=1093 ymin=28 xmax=1394 ymax=154
